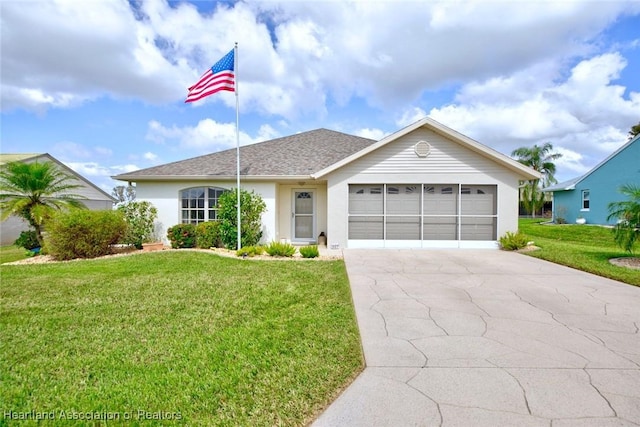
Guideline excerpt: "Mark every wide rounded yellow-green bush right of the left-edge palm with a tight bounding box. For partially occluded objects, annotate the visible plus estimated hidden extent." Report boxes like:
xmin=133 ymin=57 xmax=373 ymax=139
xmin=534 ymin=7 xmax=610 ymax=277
xmin=46 ymin=209 xmax=127 ymax=260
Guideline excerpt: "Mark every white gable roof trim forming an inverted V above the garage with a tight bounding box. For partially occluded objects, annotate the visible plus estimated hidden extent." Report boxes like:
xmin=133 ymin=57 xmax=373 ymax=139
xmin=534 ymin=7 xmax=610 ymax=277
xmin=312 ymin=117 xmax=542 ymax=179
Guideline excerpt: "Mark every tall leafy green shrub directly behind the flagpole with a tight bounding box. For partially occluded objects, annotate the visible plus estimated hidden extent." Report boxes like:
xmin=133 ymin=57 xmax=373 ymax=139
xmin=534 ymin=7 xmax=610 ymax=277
xmin=217 ymin=189 xmax=267 ymax=249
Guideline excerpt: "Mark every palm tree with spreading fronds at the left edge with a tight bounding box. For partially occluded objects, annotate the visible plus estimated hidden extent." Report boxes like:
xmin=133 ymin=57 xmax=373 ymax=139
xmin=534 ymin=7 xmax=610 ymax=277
xmin=0 ymin=162 xmax=85 ymax=246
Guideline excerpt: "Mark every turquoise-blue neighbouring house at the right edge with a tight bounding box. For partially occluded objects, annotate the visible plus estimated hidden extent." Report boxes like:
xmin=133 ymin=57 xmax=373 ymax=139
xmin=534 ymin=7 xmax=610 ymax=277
xmin=542 ymin=135 xmax=640 ymax=225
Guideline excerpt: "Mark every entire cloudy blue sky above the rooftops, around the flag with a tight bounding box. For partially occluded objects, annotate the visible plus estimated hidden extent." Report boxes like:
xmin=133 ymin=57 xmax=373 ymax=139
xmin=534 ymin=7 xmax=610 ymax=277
xmin=0 ymin=0 xmax=640 ymax=192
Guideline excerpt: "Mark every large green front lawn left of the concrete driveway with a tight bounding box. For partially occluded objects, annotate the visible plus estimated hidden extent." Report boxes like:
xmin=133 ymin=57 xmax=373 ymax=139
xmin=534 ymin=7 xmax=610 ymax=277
xmin=0 ymin=251 xmax=363 ymax=426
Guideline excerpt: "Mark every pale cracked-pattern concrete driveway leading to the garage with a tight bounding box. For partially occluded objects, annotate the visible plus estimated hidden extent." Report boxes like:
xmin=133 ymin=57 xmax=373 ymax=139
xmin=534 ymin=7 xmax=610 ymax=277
xmin=314 ymin=249 xmax=640 ymax=427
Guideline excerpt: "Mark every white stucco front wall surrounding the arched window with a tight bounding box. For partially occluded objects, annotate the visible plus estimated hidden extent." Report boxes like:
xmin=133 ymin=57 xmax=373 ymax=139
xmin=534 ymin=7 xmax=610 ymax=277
xmin=136 ymin=181 xmax=277 ymax=243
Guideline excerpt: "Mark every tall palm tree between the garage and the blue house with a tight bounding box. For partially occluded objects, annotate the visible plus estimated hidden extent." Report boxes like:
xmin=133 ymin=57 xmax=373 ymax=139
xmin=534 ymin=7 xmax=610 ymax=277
xmin=511 ymin=142 xmax=562 ymax=217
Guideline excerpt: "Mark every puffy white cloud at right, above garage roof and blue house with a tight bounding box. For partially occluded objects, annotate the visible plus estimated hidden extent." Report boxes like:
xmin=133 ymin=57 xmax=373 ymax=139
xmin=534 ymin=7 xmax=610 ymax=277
xmin=429 ymin=53 xmax=640 ymax=178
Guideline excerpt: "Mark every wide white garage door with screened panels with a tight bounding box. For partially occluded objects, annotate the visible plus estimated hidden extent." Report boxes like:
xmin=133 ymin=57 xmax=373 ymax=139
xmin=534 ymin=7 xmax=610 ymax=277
xmin=349 ymin=184 xmax=498 ymax=247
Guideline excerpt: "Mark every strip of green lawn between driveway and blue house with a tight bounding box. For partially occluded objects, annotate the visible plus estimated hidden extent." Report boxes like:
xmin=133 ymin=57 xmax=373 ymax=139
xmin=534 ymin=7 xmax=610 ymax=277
xmin=519 ymin=219 xmax=640 ymax=286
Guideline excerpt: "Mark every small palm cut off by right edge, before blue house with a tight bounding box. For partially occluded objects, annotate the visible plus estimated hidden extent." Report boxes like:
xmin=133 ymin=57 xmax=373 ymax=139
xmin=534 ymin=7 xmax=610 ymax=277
xmin=607 ymin=184 xmax=640 ymax=253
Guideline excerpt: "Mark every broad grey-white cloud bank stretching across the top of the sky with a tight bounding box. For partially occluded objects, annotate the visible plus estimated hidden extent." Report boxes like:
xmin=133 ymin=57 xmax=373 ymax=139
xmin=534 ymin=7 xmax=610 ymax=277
xmin=1 ymin=0 xmax=640 ymax=119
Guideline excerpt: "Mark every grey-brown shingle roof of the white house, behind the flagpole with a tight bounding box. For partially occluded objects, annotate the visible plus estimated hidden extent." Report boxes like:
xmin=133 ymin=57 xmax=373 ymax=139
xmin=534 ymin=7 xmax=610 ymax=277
xmin=114 ymin=129 xmax=376 ymax=181
